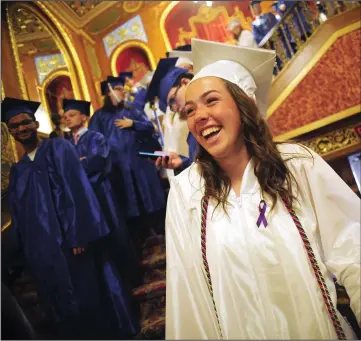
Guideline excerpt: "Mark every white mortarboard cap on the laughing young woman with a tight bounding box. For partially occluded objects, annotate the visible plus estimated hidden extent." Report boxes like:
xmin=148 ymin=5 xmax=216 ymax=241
xmin=189 ymin=38 xmax=276 ymax=117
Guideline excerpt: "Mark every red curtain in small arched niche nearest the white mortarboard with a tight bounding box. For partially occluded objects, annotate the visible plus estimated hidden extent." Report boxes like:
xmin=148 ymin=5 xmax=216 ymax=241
xmin=116 ymin=47 xmax=151 ymax=82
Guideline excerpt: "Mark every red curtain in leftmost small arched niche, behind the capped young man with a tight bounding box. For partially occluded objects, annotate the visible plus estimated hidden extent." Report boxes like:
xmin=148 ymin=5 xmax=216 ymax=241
xmin=45 ymin=75 xmax=74 ymax=115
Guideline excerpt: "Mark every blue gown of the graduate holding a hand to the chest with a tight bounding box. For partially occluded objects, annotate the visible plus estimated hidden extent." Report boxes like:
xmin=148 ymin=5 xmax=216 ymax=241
xmin=88 ymin=108 xmax=165 ymax=218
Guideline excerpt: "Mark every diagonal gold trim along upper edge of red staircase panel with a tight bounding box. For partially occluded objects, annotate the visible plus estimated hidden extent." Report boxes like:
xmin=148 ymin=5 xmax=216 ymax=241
xmin=266 ymin=21 xmax=361 ymax=119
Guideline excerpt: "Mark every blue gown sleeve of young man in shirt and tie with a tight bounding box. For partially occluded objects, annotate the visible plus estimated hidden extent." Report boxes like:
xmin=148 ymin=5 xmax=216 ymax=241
xmin=81 ymin=134 xmax=109 ymax=177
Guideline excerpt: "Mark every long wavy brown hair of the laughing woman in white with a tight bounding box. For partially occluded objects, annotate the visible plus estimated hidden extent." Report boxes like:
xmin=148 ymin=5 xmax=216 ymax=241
xmin=196 ymin=81 xmax=310 ymax=213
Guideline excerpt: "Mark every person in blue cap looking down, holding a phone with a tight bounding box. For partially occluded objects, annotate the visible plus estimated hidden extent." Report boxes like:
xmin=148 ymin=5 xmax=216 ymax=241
xmin=147 ymin=58 xmax=197 ymax=173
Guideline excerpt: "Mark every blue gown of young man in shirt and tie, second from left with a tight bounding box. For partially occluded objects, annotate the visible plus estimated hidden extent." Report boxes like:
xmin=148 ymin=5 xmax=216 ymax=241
xmin=71 ymin=130 xmax=140 ymax=286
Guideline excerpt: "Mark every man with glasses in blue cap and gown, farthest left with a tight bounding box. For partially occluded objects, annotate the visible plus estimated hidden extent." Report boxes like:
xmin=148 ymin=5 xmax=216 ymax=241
xmin=2 ymin=97 xmax=139 ymax=339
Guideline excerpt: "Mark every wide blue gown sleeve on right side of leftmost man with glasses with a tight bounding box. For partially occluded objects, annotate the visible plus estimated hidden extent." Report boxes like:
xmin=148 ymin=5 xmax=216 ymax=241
xmin=49 ymin=139 xmax=109 ymax=248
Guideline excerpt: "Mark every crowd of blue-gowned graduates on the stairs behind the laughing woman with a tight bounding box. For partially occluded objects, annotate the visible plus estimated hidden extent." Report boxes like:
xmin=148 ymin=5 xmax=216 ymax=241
xmin=2 ymin=39 xmax=196 ymax=339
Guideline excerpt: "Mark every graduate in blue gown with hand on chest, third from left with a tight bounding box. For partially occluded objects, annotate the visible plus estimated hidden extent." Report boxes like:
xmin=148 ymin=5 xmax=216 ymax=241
xmin=89 ymin=77 xmax=165 ymax=239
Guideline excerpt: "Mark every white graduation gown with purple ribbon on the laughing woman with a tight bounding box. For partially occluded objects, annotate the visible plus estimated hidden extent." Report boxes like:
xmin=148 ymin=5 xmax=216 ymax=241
xmin=166 ymin=144 xmax=360 ymax=340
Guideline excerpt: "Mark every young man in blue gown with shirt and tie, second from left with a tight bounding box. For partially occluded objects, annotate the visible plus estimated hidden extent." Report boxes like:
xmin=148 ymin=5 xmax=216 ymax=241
xmin=63 ymin=99 xmax=140 ymax=287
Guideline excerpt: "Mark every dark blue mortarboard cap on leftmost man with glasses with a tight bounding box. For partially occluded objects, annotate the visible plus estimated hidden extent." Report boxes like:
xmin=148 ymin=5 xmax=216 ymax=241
xmin=1 ymin=97 xmax=41 ymax=124
